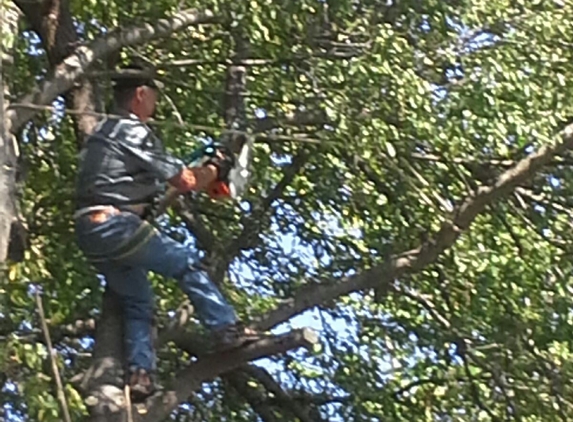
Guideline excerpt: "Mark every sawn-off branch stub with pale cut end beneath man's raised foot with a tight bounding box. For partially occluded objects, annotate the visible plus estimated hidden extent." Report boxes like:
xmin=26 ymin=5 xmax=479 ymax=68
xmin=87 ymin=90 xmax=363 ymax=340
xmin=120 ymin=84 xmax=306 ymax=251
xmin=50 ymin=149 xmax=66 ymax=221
xmin=140 ymin=329 xmax=318 ymax=422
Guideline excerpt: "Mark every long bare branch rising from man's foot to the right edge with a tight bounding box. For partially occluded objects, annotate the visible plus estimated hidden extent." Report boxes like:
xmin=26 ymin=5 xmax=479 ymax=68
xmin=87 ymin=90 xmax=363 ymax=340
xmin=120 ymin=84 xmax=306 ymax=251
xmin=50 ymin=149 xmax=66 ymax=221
xmin=252 ymin=124 xmax=573 ymax=329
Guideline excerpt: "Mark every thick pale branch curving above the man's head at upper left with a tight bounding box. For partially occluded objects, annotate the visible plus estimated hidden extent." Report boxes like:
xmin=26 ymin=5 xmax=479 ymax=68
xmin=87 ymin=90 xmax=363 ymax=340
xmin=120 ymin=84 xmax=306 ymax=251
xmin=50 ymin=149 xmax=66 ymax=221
xmin=7 ymin=10 xmax=214 ymax=133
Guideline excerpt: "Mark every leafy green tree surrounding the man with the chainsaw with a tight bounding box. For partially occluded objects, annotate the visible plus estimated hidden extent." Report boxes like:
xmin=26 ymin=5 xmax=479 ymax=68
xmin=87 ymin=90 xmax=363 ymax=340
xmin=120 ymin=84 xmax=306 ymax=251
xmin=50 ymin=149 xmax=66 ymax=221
xmin=0 ymin=0 xmax=573 ymax=421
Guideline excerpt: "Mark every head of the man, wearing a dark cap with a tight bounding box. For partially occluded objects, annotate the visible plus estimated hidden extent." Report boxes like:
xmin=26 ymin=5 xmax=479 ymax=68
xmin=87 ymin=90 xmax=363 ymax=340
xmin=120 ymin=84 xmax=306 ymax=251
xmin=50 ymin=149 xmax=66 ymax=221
xmin=113 ymin=65 xmax=163 ymax=122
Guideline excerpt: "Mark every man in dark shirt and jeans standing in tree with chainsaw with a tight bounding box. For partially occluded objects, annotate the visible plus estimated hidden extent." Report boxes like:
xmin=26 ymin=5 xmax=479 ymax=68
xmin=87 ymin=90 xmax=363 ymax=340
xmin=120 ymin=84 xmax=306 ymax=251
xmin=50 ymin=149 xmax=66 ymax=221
xmin=75 ymin=67 xmax=258 ymax=400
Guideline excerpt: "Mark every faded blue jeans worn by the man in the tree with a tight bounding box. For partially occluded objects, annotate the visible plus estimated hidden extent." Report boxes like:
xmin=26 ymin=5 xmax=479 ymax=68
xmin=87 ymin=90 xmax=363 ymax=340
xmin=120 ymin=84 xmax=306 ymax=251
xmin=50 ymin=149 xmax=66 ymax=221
xmin=76 ymin=212 xmax=237 ymax=371
